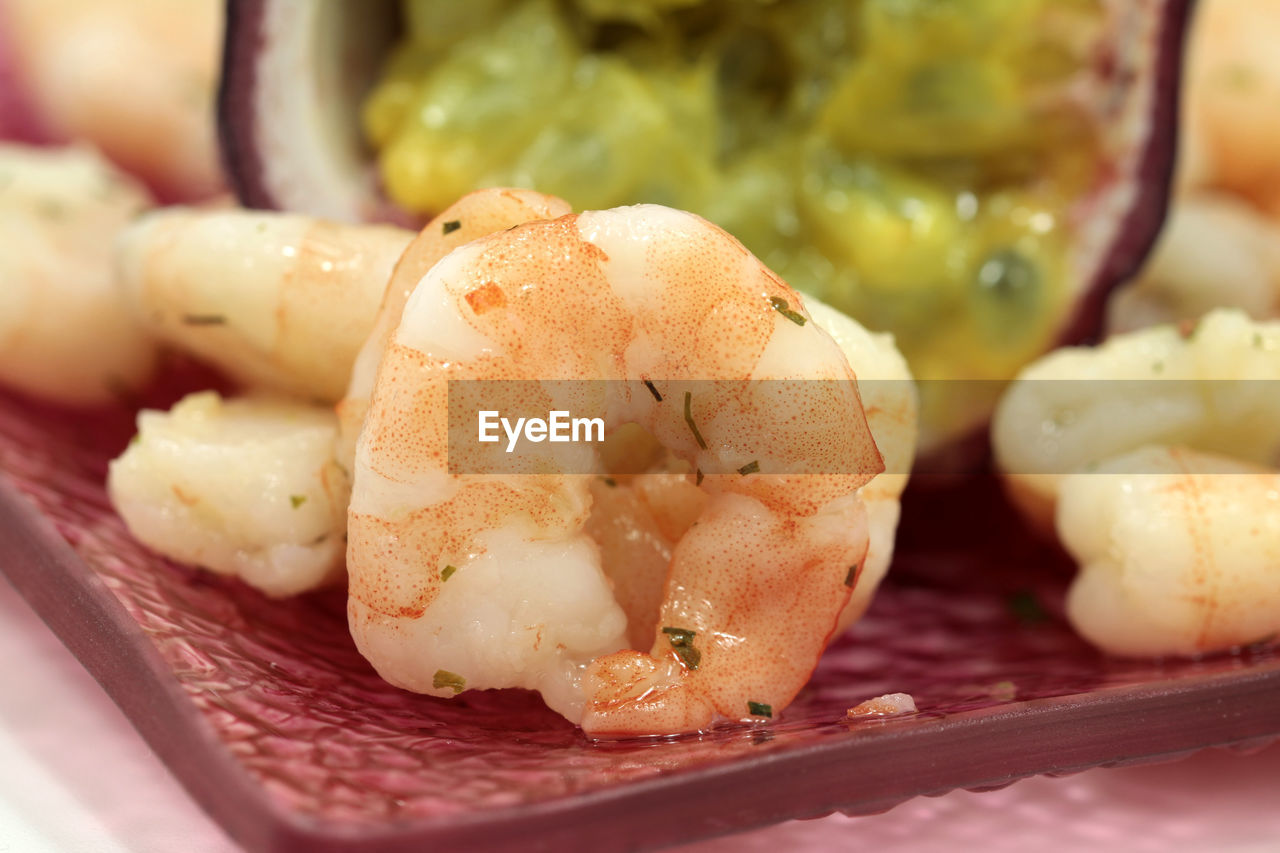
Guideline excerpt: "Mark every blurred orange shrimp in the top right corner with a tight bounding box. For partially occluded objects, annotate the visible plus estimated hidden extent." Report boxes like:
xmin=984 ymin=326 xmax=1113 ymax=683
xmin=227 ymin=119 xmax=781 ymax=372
xmin=1180 ymin=0 xmax=1280 ymax=218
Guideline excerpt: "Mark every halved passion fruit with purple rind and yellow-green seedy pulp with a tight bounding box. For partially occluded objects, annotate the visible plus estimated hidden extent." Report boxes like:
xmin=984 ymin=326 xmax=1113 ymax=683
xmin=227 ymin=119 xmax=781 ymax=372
xmin=220 ymin=0 xmax=1190 ymax=446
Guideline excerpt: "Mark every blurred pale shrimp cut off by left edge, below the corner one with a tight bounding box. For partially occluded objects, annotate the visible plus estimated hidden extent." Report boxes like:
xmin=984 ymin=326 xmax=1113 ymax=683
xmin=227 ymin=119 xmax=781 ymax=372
xmin=0 ymin=145 xmax=156 ymax=405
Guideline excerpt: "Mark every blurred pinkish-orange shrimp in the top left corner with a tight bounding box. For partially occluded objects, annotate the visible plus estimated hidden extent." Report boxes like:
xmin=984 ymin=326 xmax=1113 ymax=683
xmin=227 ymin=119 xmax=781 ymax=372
xmin=0 ymin=0 xmax=223 ymax=199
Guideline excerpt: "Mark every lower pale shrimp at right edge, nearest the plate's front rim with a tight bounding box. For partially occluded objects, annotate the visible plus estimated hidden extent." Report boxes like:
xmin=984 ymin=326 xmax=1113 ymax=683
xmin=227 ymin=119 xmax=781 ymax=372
xmin=1057 ymin=447 xmax=1280 ymax=656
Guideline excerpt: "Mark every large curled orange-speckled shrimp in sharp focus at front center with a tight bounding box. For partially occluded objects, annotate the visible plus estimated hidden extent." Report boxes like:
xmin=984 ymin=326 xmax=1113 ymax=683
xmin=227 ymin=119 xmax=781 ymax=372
xmin=347 ymin=206 xmax=883 ymax=734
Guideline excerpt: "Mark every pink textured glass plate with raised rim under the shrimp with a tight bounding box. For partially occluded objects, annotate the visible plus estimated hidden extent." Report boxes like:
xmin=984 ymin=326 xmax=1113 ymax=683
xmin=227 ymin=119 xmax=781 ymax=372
xmin=0 ymin=377 xmax=1280 ymax=850
